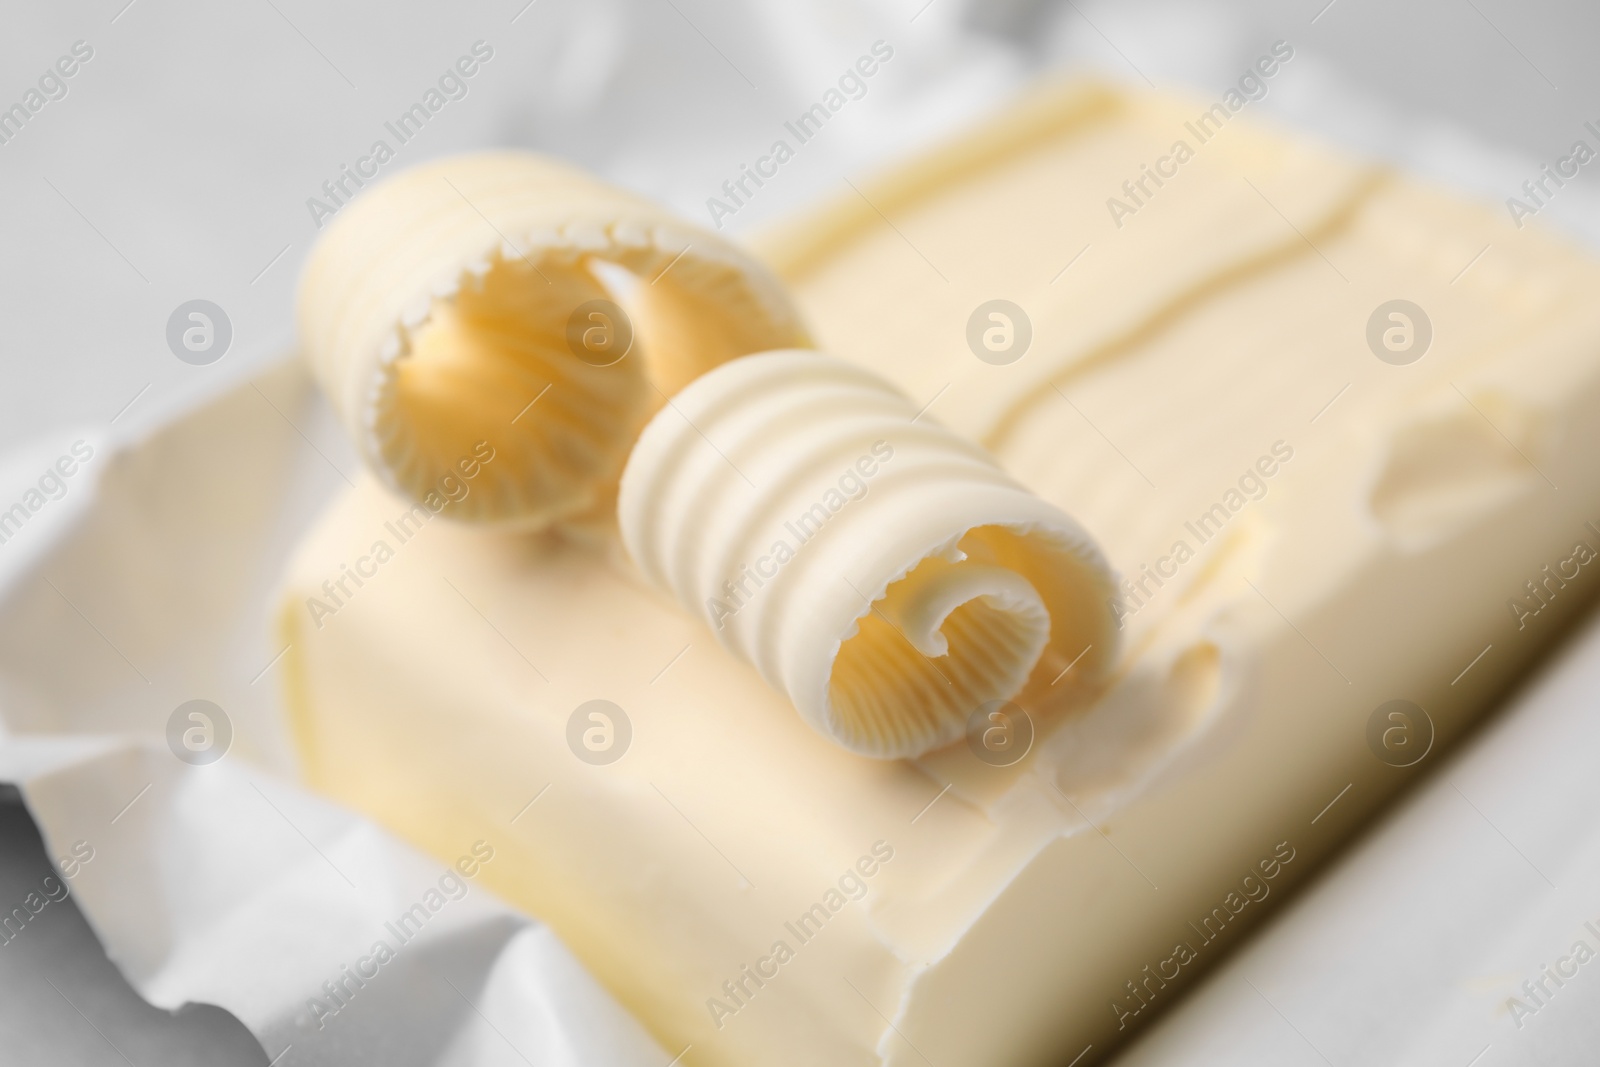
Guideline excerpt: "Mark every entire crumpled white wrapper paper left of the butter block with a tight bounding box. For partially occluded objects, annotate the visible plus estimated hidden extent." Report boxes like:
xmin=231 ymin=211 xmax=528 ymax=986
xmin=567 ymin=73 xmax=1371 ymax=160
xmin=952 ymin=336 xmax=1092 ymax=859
xmin=0 ymin=362 xmax=670 ymax=1067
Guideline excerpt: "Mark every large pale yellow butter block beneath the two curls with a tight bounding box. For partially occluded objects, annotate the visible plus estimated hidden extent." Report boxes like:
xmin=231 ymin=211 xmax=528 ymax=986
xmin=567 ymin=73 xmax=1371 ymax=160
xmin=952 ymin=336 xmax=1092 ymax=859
xmin=280 ymin=86 xmax=1600 ymax=1067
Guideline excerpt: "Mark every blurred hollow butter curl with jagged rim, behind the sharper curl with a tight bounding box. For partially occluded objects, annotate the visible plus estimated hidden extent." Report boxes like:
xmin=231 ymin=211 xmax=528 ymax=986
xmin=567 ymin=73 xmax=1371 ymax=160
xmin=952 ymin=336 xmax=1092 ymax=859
xmin=299 ymin=152 xmax=806 ymax=526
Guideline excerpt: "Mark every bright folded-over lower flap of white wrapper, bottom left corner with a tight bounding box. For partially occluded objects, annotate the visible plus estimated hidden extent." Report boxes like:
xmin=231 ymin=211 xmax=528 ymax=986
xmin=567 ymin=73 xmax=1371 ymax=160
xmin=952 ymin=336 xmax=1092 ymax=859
xmin=0 ymin=736 xmax=669 ymax=1067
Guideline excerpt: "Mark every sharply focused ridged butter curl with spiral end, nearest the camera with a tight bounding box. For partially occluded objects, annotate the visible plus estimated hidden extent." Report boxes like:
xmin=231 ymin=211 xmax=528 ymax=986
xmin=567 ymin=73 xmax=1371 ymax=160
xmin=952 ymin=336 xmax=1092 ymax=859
xmin=618 ymin=350 xmax=1117 ymax=758
